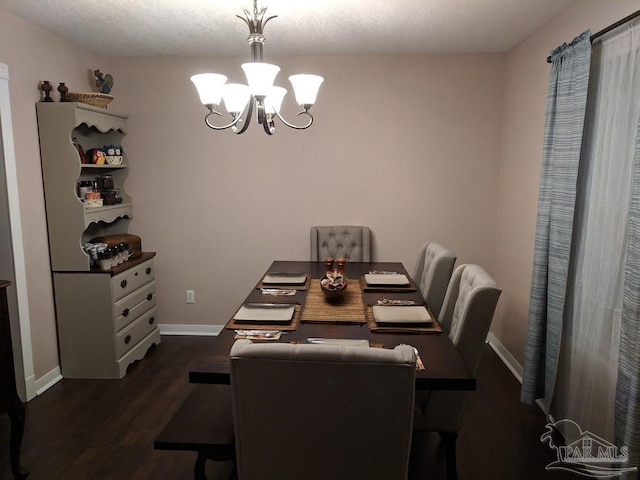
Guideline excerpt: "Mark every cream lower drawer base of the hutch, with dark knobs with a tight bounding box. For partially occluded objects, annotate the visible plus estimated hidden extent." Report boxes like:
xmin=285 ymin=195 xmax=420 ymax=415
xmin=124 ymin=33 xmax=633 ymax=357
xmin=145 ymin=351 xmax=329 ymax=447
xmin=53 ymin=253 xmax=160 ymax=378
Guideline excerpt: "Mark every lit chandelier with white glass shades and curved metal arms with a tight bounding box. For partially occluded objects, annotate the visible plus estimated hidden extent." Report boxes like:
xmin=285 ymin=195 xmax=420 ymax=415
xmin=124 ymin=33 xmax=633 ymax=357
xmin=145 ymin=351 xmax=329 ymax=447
xmin=191 ymin=0 xmax=324 ymax=135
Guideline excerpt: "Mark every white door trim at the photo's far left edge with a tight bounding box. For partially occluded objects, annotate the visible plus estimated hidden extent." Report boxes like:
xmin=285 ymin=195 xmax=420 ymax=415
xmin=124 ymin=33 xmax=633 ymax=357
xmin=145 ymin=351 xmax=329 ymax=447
xmin=0 ymin=63 xmax=35 ymax=402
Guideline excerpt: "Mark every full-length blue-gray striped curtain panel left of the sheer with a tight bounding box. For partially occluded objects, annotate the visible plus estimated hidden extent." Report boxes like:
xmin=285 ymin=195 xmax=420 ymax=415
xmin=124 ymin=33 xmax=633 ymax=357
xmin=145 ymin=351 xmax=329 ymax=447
xmin=521 ymin=31 xmax=591 ymax=412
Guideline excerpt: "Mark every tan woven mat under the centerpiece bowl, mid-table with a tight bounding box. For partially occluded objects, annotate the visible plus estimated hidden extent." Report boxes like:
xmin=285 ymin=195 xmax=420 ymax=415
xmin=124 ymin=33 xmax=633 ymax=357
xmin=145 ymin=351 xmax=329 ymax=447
xmin=301 ymin=278 xmax=367 ymax=323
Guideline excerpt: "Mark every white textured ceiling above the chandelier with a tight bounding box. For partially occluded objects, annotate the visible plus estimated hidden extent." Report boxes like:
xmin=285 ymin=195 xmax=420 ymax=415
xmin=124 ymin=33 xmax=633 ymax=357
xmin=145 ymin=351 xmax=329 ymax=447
xmin=0 ymin=0 xmax=576 ymax=56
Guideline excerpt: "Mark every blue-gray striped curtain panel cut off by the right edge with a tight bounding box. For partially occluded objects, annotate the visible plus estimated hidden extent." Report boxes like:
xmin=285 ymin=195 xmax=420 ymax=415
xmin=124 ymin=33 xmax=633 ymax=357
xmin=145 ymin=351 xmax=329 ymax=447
xmin=615 ymin=112 xmax=640 ymax=478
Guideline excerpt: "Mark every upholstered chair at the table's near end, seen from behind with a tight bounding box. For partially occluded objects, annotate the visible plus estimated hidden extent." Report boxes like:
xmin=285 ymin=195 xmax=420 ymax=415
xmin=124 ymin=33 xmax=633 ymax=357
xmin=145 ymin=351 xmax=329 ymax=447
xmin=231 ymin=340 xmax=416 ymax=480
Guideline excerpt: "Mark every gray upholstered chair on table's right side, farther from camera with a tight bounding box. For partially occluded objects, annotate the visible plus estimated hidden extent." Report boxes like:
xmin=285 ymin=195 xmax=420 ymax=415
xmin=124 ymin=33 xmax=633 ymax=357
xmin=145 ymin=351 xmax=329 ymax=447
xmin=413 ymin=242 xmax=457 ymax=318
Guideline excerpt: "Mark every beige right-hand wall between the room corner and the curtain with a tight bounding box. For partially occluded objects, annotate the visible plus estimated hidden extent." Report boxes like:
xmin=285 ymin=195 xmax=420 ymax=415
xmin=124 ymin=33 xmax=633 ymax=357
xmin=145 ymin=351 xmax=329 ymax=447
xmin=492 ymin=0 xmax=640 ymax=364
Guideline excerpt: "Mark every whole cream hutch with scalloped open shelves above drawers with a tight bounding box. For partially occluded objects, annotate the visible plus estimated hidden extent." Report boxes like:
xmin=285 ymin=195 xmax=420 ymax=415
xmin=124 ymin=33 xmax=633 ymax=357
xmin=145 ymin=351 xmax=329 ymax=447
xmin=37 ymin=102 xmax=160 ymax=378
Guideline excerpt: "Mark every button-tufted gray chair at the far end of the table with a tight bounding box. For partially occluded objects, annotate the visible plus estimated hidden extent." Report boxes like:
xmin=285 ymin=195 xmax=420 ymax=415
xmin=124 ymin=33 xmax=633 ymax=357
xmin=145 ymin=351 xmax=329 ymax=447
xmin=311 ymin=225 xmax=371 ymax=262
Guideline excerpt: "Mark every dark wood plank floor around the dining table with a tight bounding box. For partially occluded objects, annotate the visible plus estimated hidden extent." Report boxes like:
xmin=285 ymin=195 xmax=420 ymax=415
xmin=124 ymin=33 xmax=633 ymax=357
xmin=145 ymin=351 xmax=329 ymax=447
xmin=0 ymin=337 xmax=576 ymax=480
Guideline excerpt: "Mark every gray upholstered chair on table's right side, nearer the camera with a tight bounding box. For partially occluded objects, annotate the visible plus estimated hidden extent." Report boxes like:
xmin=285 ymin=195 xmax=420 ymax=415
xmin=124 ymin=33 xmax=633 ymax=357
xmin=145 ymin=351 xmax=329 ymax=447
xmin=414 ymin=265 xmax=502 ymax=480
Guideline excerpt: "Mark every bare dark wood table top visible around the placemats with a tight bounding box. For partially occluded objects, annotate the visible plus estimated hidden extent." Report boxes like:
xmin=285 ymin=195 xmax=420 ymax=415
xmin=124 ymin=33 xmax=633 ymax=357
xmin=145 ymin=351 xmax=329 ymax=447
xmin=189 ymin=261 xmax=476 ymax=390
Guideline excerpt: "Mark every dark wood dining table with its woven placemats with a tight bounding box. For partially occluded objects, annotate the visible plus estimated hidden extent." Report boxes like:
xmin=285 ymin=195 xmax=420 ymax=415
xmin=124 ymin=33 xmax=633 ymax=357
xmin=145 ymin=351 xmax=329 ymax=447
xmin=189 ymin=260 xmax=476 ymax=391
